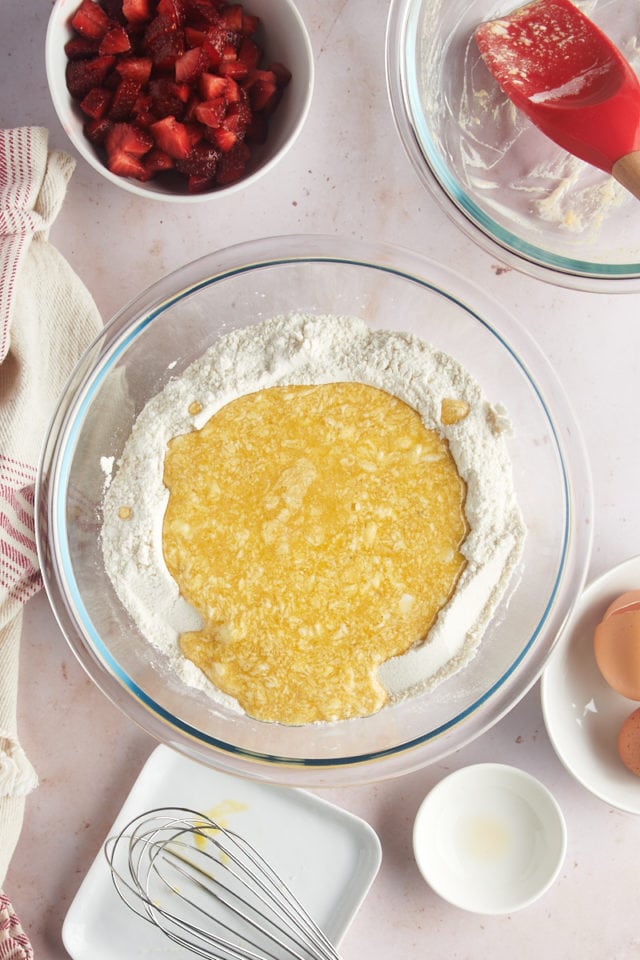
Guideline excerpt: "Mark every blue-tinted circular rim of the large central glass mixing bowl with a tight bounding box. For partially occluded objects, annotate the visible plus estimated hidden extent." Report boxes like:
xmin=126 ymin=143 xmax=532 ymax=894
xmin=53 ymin=255 xmax=571 ymax=768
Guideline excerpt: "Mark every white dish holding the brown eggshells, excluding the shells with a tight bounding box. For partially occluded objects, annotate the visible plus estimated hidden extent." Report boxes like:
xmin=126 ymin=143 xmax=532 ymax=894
xmin=540 ymin=557 xmax=640 ymax=814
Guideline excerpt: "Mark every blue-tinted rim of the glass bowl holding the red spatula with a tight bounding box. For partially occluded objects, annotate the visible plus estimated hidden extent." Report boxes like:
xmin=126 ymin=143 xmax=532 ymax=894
xmin=387 ymin=0 xmax=640 ymax=290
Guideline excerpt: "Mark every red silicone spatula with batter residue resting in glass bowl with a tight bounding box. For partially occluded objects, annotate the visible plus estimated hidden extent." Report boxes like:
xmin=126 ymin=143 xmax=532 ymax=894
xmin=475 ymin=0 xmax=640 ymax=199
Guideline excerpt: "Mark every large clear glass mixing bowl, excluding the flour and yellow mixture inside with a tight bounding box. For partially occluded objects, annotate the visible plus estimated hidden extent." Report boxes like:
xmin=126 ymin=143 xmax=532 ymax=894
xmin=37 ymin=237 xmax=592 ymax=786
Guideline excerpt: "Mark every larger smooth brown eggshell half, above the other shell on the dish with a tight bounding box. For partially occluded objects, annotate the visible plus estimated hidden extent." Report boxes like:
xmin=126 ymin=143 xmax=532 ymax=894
xmin=593 ymin=609 xmax=640 ymax=700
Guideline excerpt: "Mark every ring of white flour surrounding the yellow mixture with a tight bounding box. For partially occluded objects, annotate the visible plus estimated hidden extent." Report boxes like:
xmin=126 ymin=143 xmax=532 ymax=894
xmin=102 ymin=315 xmax=525 ymax=710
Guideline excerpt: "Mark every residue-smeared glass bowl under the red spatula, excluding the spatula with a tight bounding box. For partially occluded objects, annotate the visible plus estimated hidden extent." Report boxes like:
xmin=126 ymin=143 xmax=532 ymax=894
xmin=387 ymin=0 xmax=640 ymax=293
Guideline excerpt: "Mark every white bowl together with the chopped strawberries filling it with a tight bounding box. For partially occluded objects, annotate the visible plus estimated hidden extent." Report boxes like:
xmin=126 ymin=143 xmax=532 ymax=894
xmin=46 ymin=0 xmax=314 ymax=203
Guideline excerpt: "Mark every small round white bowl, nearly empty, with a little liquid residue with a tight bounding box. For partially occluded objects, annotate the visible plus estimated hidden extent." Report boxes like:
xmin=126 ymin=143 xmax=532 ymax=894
xmin=413 ymin=763 xmax=567 ymax=915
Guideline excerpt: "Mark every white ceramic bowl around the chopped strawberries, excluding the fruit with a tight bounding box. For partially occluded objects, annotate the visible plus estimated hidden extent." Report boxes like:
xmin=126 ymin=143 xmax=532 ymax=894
xmin=45 ymin=0 xmax=314 ymax=203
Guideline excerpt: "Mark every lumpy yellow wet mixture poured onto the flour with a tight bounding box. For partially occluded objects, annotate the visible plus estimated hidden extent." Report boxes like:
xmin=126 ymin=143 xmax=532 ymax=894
xmin=163 ymin=383 xmax=468 ymax=724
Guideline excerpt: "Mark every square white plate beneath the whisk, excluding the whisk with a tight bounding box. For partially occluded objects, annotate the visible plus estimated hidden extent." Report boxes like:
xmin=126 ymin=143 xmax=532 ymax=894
xmin=62 ymin=746 xmax=381 ymax=960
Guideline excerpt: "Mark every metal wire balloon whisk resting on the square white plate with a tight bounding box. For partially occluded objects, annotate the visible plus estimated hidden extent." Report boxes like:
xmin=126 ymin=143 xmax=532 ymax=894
xmin=105 ymin=807 xmax=340 ymax=960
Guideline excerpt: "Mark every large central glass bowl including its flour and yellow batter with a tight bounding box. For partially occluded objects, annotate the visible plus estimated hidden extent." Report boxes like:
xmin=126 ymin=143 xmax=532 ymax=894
xmin=37 ymin=237 xmax=591 ymax=786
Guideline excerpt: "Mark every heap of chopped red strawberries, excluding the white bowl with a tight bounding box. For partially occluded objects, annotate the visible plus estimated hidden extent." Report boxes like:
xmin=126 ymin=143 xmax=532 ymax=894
xmin=65 ymin=0 xmax=291 ymax=193
